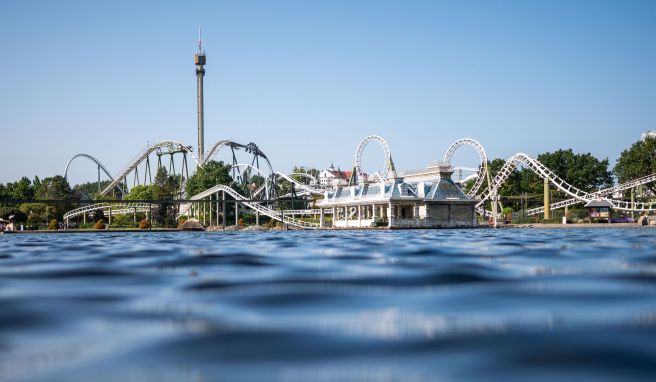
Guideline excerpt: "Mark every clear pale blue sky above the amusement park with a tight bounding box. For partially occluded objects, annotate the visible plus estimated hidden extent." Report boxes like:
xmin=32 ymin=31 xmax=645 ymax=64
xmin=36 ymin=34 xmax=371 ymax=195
xmin=0 ymin=0 xmax=656 ymax=184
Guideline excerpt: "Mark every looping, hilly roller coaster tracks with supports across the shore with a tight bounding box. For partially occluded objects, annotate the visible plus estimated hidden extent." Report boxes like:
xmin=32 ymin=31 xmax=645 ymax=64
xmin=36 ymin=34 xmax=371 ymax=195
xmin=64 ymin=135 xmax=656 ymax=229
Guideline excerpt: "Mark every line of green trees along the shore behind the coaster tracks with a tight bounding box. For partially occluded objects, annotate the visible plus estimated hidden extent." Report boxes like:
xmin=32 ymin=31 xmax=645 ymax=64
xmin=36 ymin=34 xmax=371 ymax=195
xmin=0 ymin=137 xmax=656 ymax=225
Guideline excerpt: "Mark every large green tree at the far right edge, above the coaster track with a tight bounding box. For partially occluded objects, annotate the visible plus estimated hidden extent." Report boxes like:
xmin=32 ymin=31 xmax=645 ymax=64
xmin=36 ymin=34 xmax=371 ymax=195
xmin=613 ymin=138 xmax=656 ymax=193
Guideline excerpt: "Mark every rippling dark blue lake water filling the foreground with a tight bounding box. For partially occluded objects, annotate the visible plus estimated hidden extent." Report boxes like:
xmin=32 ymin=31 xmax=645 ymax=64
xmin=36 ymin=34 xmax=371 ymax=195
xmin=0 ymin=228 xmax=656 ymax=381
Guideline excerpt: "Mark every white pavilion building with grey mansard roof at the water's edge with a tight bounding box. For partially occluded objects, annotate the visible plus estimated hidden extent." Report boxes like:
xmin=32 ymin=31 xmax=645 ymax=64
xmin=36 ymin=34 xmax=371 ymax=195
xmin=317 ymin=166 xmax=478 ymax=228
